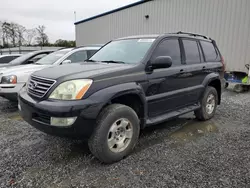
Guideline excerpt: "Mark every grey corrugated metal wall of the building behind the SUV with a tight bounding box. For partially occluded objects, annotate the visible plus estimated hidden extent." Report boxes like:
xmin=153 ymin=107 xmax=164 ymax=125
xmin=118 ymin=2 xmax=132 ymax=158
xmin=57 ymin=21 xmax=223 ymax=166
xmin=76 ymin=0 xmax=250 ymax=71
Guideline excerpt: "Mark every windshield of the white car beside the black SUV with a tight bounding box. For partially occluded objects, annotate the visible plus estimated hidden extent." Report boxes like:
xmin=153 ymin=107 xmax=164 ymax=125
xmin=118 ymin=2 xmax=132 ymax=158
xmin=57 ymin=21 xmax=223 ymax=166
xmin=35 ymin=49 xmax=71 ymax=65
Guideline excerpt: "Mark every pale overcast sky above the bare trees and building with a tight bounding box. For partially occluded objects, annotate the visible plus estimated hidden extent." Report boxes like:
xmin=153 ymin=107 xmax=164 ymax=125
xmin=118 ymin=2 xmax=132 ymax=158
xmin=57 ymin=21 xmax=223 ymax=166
xmin=0 ymin=0 xmax=139 ymax=42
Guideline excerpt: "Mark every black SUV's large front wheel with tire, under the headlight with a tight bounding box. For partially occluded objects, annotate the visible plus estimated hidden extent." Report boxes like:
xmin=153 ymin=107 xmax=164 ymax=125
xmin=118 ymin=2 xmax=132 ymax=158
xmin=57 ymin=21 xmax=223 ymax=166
xmin=88 ymin=104 xmax=140 ymax=163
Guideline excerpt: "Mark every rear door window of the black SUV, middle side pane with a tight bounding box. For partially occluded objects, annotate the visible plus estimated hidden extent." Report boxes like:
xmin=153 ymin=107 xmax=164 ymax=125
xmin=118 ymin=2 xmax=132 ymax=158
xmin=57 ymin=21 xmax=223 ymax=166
xmin=182 ymin=40 xmax=201 ymax=64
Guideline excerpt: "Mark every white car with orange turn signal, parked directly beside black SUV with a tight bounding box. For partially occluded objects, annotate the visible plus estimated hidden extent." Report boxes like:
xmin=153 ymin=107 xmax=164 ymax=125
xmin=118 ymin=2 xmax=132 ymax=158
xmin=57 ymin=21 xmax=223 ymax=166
xmin=0 ymin=47 xmax=100 ymax=101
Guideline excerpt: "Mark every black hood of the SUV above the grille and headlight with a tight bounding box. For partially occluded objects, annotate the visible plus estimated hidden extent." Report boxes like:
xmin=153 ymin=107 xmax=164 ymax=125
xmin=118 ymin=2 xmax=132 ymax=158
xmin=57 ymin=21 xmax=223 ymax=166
xmin=34 ymin=62 xmax=133 ymax=80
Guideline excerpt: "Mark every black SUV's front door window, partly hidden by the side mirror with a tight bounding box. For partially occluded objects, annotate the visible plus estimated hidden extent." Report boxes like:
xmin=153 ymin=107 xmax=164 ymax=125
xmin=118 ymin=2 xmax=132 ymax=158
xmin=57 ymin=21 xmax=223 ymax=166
xmin=153 ymin=39 xmax=181 ymax=66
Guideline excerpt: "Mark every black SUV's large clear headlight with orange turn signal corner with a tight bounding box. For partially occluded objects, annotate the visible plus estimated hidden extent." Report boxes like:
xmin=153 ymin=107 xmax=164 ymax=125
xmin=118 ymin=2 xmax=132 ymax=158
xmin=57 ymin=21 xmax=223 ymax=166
xmin=49 ymin=79 xmax=93 ymax=100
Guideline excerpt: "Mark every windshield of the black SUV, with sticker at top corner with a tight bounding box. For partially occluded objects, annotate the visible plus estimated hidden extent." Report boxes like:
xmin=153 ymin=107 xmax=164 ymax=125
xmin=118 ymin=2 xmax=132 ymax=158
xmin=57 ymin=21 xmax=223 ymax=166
xmin=89 ymin=38 xmax=155 ymax=64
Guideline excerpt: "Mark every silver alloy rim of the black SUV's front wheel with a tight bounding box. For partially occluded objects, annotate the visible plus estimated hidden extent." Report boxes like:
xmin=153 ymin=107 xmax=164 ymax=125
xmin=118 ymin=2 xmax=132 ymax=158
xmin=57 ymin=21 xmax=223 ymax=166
xmin=108 ymin=118 xmax=133 ymax=153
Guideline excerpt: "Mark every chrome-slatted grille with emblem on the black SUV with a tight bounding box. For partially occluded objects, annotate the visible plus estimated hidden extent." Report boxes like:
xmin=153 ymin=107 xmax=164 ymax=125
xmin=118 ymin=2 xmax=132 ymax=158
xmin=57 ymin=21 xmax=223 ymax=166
xmin=27 ymin=76 xmax=56 ymax=98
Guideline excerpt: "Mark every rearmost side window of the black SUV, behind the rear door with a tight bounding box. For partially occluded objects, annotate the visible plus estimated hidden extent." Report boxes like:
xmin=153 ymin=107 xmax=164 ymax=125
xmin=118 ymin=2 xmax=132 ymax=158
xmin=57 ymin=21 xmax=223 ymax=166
xmin=200 ymin=41 xmax=220 ymax=61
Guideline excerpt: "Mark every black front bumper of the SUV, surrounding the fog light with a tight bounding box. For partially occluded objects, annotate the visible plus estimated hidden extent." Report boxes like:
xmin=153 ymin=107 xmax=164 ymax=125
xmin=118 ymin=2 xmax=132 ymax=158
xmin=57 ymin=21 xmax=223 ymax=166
xmin=18 ymin=89 xmax=102 ymax=139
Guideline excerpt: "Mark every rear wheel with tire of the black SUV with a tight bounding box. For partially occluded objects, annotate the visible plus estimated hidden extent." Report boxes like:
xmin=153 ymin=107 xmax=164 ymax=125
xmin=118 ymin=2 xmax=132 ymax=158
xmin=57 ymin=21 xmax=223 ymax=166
xmin=194 ymin=86 xmax=218 ymax=121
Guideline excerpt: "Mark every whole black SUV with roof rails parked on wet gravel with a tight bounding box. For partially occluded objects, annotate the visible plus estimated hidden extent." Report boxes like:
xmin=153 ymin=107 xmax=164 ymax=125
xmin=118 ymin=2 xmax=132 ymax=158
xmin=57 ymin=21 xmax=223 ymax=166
xmin=19 ymin=32 xmax=224 ymax=163
